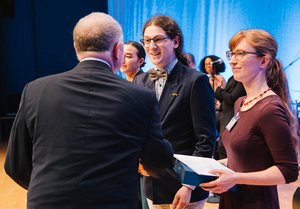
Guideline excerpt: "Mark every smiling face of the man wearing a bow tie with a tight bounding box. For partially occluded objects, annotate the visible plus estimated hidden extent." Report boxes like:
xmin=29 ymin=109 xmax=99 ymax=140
xmin=144 ymin=25 xmax=179 ymax=68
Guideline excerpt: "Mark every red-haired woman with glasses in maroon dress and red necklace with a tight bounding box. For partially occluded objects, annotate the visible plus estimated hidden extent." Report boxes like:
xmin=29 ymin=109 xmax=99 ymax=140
xmin=200 ymin=29 xmax=299 ymax=209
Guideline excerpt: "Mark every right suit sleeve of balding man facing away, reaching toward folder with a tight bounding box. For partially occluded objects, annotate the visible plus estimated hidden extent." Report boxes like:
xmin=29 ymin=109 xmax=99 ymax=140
xmin=141 ymin=92 xmax=173 ymax=177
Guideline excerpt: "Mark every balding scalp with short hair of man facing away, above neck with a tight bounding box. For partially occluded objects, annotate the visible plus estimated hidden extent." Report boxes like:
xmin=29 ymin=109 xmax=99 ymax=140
xmin=73 ymin=12 xmax=123 ymax=53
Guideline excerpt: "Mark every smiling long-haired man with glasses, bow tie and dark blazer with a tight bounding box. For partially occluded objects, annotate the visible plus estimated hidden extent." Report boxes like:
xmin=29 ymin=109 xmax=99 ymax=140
xmin=134 ymin=16 xmax=216 ymax=209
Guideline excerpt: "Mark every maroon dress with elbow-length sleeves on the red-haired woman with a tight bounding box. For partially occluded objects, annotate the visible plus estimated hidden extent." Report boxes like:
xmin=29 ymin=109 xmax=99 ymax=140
xmin=219 ymin=95 xmax=298 ymax=209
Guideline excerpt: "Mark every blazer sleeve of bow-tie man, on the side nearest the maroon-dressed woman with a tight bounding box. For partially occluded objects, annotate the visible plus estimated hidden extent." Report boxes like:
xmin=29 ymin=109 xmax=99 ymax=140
xmin=190 ymin=75 xmax=216 ymax=157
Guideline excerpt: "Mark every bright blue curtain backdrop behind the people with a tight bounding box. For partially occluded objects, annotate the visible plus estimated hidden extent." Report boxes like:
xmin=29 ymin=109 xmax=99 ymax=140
xmin=108 ymin=0 xmax=300 ymax=100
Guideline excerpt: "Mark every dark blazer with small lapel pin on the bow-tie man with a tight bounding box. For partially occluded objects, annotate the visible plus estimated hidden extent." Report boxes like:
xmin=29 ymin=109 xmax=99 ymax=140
xmin=134 ymin=62 xmax=216 ymax=204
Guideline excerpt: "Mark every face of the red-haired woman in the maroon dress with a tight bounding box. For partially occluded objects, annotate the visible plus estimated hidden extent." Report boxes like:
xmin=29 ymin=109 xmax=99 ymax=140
xmin=230 ymin=39 xmax=265 ymax=84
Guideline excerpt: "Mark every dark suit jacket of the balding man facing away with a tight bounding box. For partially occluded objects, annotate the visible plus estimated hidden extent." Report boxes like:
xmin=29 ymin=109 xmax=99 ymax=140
xmin=5 ymin=60 xmax=173 ymax=209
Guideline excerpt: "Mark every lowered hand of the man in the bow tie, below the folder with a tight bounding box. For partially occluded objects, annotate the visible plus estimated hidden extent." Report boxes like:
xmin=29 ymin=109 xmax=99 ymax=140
xmin=172 ymin=186 xmax=192 ymax=209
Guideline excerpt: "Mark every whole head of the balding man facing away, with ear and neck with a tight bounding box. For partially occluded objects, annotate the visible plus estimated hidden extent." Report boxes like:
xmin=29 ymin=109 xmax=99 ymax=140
xmin=73 ymin=12 xmax=124 ymax=73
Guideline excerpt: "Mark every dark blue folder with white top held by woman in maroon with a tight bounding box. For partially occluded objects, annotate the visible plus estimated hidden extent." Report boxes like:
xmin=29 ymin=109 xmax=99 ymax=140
xmin=174 ymin=154 xmax=236 ymax=191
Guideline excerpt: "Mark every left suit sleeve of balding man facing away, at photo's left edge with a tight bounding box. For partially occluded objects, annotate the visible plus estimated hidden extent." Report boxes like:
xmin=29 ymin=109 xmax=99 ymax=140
xmin=4 ymin=86 xmax=32 ymax=189
